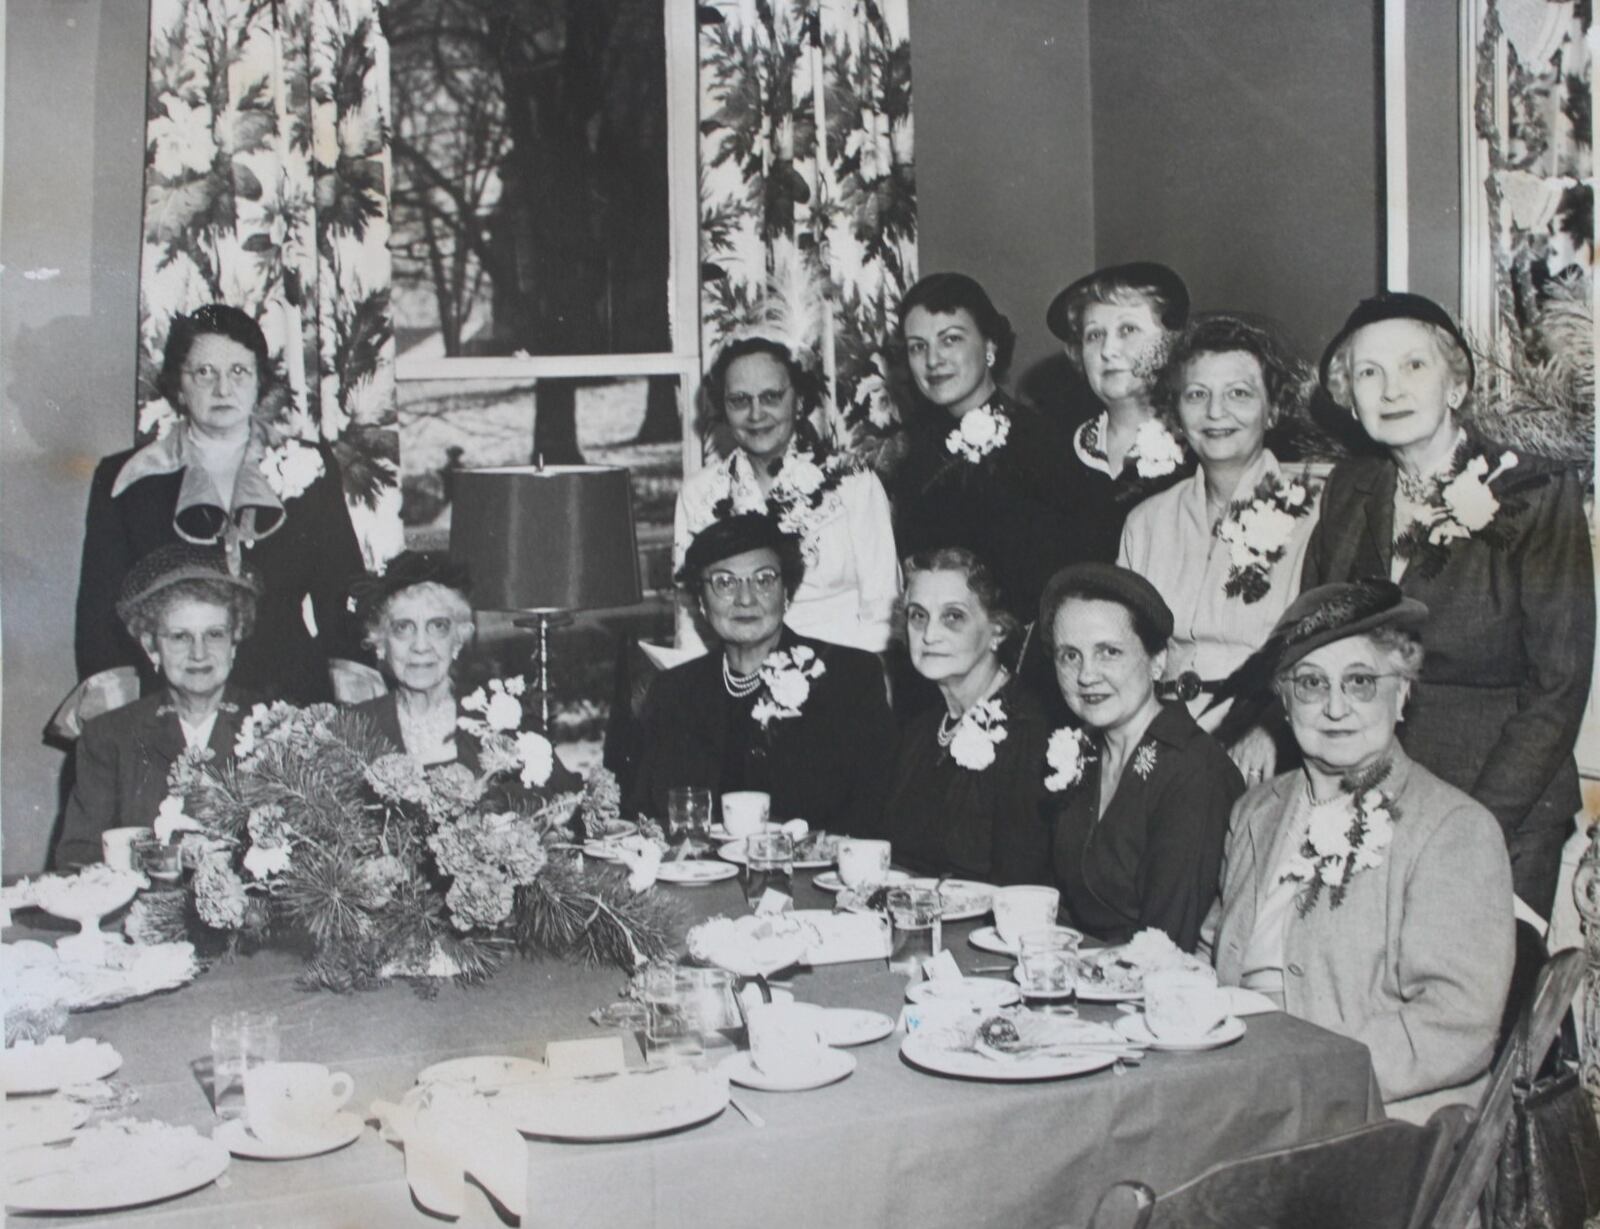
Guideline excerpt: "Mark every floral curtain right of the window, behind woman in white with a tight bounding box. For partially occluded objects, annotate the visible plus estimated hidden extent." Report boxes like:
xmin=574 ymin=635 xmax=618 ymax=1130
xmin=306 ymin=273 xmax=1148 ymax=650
xmin=699 ymin=0 xmax=917 ymax=470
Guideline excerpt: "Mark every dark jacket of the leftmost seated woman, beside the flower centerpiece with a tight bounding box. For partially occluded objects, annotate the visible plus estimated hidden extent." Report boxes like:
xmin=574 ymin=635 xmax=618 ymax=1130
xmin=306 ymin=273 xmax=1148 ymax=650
xmin=51 ymin=683 xmax=254 ymax=869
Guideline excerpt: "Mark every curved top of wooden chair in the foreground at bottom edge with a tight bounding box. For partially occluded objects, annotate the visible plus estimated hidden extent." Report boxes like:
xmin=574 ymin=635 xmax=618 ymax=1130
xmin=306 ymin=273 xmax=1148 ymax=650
xmin=1091 ymin=1106 xmax=1470 ymax=1229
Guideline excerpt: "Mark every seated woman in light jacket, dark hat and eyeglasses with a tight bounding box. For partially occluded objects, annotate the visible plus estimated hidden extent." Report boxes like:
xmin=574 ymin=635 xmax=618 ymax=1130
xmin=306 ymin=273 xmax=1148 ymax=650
xmin=1208 ymin=581 xmax=1515 ymax=1122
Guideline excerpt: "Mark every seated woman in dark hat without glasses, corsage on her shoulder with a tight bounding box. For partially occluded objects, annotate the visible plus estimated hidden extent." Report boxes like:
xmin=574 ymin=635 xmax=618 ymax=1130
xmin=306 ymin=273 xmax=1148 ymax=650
xmin=1038 ymin=563 xmax=1245 ymax=952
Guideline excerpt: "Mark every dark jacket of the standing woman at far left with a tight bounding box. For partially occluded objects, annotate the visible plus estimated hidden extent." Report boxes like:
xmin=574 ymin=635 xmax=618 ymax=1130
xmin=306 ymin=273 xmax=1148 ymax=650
xmin=77 ymin=445 xmax=365 ymax=704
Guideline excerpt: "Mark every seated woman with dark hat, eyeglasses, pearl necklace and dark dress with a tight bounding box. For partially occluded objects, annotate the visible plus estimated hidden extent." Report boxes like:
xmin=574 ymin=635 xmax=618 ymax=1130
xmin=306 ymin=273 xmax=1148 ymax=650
xmin=626 ymin=512 xmax=893 ymax=835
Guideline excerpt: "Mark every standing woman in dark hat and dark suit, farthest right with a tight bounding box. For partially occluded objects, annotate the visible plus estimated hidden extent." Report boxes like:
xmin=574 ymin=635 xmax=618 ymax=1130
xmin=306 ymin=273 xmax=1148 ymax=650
xmin=1304 ymin=293 xmax=1595 ymax=915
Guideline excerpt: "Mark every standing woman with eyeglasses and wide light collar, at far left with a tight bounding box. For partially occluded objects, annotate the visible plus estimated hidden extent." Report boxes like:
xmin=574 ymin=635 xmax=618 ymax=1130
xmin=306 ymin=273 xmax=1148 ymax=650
xmin=77 ymin=302 xmax=365 ymax=701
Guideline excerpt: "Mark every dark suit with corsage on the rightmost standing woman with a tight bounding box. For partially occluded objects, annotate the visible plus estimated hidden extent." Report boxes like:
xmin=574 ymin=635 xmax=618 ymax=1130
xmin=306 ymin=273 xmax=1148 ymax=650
xmin=1302 ymin=437 xmax=1595 ymax=915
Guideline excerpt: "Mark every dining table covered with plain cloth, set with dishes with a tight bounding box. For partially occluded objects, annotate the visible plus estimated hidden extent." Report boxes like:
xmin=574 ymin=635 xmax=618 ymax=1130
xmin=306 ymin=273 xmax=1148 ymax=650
xmin=5 ymin=871 xmax=1382 ymax=1229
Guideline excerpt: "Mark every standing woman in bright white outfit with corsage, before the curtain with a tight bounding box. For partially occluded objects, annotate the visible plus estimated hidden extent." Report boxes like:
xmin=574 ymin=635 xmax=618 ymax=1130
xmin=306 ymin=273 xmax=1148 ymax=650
xmin=672 ymin=336 xmax=899 ymax=653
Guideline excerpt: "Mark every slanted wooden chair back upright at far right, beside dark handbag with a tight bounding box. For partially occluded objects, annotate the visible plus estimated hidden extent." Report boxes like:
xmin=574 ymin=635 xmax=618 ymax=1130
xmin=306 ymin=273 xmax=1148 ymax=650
xmin=1411 ymin=947 xmax=1584 ymax=1229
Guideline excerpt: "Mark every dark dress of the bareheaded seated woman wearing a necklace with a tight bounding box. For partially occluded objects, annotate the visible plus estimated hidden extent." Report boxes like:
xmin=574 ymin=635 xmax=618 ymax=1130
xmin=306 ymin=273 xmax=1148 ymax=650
xmin=882 ymin=679 xmax=1051 ymax=883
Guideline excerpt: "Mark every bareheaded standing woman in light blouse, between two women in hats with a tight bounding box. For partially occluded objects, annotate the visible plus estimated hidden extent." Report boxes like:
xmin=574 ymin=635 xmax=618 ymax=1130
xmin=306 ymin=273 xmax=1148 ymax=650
xmin=1117 ymin=312 xmax=1317 ymax=781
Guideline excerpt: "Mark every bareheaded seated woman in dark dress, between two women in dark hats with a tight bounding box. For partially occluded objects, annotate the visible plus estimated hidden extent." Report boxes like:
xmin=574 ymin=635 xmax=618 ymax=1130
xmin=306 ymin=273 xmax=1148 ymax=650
xmin=883 ymin=547 xmax=1050 ymax=883
